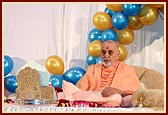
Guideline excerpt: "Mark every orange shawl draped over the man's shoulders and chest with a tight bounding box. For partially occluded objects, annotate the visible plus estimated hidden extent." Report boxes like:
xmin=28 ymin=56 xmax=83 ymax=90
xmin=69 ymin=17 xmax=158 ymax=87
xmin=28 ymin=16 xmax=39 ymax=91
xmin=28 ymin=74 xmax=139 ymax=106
xmin=76 ymin=61 xmax=140 ymax=93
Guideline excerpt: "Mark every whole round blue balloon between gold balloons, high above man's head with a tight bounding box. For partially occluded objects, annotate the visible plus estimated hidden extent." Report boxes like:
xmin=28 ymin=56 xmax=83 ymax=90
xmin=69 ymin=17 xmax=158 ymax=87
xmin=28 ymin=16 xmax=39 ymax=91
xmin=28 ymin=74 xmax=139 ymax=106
xmin=112 ymin=12 xmax=128 ymax=30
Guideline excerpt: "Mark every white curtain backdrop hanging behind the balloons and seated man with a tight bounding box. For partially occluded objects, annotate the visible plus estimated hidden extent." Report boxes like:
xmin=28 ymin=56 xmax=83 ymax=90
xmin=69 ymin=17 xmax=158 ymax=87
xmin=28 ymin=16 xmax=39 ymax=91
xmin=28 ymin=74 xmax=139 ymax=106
xmin=3 ymin=3 xmax=165 ymax=74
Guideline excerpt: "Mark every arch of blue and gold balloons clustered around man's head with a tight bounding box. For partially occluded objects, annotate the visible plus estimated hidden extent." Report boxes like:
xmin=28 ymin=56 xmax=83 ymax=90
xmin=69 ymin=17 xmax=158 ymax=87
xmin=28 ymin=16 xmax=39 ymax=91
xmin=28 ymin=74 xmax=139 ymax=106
xmin=86 ymin=4 xmax=164 ymax=65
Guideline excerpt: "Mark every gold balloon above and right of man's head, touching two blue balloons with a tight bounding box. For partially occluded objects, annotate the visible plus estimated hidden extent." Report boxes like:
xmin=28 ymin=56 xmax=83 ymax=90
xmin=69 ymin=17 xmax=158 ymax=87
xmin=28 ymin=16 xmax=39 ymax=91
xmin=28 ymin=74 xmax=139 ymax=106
xmin=117 ymin=28 xmax=134 ymax=45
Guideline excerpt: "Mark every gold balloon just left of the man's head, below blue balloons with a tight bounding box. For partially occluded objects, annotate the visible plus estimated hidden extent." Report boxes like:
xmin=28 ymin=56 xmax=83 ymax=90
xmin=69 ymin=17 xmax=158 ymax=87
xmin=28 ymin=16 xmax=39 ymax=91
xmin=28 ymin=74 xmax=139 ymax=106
xmin=88 ymin=40 xmax=102 ymax=57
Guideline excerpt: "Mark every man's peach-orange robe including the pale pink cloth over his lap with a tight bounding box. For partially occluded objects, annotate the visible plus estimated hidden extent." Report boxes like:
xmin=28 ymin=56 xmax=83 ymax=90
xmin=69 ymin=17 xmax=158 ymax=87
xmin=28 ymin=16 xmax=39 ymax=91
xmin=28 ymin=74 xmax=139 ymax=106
xmin=58 ymin=61 xmax=140 ymax=106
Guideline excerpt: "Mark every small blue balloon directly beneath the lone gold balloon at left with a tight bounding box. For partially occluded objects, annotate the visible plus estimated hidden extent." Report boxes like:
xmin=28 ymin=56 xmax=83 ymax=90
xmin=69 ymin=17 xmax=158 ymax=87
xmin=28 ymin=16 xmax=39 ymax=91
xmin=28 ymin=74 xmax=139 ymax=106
xmin=49 ymin=74 xmax=64 ymax=88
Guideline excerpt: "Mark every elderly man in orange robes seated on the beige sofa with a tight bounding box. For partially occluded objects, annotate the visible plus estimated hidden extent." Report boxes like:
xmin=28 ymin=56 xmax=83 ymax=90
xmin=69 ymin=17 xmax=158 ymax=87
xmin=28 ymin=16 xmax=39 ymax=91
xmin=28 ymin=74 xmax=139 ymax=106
xmin=59 ymin=40 xmax=140 ymax=107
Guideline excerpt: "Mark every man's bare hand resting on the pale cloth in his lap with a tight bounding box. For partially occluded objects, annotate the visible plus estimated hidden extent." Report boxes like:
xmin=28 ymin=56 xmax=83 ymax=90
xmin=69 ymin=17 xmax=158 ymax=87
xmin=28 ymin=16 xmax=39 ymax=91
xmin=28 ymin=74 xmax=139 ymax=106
xmin=101 ymin=87 xmax=122 ymax=97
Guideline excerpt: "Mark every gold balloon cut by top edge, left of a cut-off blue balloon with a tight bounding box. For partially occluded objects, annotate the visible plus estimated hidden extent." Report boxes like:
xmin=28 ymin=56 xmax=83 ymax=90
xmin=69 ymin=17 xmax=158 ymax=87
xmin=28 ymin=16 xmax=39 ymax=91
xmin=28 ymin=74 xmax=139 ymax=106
xmin=106 ymin=4 xmax=122 ymax=12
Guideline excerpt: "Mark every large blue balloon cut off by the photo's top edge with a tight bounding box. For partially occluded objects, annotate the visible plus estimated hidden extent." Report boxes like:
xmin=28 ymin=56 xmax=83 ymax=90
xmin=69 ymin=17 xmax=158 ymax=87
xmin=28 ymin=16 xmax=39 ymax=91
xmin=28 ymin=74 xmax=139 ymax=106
xmin=122 ymin=4 xmax=141 ymax=16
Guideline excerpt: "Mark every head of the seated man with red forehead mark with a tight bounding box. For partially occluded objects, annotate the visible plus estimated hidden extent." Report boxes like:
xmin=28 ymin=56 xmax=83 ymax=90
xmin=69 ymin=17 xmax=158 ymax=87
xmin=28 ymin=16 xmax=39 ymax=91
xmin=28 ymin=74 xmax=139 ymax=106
xmin=101 ymin=40 xmax=119 ymax=67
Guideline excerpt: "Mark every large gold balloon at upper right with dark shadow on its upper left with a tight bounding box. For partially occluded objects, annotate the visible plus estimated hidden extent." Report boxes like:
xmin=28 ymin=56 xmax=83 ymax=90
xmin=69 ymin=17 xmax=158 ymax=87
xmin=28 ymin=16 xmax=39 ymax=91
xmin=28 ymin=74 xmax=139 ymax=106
xmin=138 ymin=5 xmax=158 ymax=25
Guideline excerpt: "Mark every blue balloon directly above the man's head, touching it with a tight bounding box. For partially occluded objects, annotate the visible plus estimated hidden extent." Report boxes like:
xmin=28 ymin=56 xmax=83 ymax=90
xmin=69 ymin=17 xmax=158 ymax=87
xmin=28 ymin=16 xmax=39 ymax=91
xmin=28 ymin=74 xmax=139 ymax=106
xmin=102 ymin=29 xmax=118 ymax=42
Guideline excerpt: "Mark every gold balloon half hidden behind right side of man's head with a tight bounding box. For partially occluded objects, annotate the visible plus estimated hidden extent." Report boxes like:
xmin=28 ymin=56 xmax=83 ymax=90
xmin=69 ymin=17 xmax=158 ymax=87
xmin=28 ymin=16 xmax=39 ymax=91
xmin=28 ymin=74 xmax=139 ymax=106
xmin=119 ymin=44 xmax=128 ymax=61
